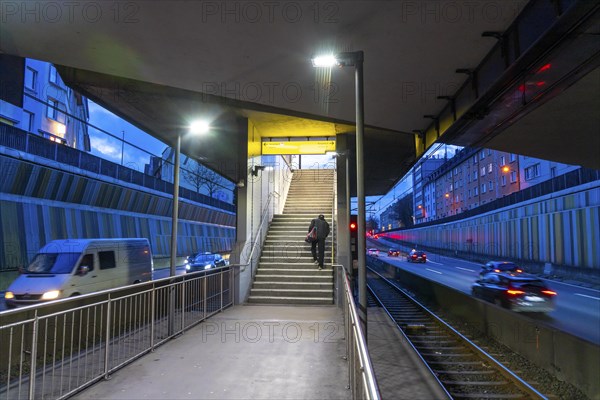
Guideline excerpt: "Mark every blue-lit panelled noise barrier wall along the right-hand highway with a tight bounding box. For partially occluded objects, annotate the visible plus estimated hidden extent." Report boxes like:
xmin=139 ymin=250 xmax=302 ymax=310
xmin=391 ymin=183 xmax=600 ymax=269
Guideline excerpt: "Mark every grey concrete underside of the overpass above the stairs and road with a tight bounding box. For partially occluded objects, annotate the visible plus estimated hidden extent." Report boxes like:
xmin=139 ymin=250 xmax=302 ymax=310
xmin=0 ymin=0 xmax=600 ymax=195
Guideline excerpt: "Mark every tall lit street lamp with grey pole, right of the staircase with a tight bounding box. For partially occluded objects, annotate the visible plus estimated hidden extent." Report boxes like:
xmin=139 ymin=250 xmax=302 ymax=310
xmin=312 ymin=50 xmax=367 ymax=337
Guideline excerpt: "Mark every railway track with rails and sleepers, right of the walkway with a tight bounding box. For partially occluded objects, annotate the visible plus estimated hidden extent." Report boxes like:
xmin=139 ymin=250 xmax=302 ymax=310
xmin=367 ymin=270 xmax=546 ymax=399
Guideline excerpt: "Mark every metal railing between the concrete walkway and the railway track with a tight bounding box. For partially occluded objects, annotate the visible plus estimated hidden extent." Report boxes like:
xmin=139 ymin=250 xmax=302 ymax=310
xmin=342 ymin=272 xmax=381 ymax=400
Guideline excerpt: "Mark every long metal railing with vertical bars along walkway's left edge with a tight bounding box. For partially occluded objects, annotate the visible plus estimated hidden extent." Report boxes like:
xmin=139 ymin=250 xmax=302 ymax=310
xmin=0 ymin=266 xmax=234 ymax=400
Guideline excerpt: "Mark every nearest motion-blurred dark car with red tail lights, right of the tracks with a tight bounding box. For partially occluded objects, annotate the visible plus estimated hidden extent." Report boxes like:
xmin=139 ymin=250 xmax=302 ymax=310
xmin=471 ymin=271 xmax=556 ymax=313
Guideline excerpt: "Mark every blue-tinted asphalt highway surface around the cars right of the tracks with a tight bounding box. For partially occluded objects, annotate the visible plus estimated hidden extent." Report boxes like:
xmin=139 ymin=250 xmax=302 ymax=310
xmin=367 ymin=239 xmax=600 ymax=344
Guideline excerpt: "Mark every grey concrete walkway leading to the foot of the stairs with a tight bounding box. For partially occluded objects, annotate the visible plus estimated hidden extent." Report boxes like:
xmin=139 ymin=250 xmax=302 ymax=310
xmin=73 ymin=305 xmax=351 ymax=399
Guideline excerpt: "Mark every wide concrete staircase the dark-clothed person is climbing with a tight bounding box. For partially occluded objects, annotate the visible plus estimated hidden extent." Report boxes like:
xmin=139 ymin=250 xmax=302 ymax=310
xmin=248 ymin=169 xmax=334 ymax=305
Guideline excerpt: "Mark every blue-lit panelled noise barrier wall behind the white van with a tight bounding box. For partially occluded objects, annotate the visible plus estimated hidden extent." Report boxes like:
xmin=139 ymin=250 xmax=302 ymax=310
xmin=0 ymin=155 xmax=236 ymax=270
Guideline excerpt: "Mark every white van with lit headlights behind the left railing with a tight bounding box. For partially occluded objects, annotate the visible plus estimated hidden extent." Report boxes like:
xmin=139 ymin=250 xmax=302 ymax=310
xmin=4 ymin=239 xmax=153 ymax=307
